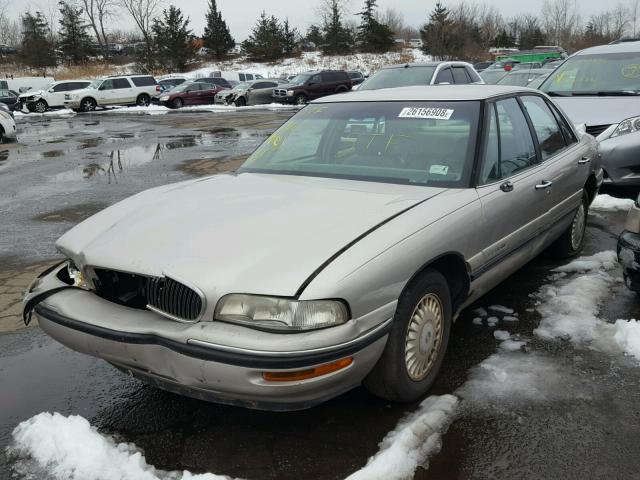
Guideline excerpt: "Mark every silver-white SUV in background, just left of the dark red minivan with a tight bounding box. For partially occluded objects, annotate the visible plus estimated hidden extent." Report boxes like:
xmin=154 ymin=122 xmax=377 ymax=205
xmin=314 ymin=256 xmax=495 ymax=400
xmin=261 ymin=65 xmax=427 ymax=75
xmin=64 ymin=75 xmax=160 ymax=112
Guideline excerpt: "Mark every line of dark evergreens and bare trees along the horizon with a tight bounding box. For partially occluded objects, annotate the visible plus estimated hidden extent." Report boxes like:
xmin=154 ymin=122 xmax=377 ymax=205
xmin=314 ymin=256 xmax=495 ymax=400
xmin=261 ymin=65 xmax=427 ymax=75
xmin=10 ymin=0 xmax=640 ymax=71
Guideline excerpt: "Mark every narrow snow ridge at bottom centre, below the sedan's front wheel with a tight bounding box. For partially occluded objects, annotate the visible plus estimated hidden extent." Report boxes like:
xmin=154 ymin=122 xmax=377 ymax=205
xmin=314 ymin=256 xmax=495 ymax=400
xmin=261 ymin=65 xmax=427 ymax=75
xmin=347 ymin=395 xmax=458 ymax=480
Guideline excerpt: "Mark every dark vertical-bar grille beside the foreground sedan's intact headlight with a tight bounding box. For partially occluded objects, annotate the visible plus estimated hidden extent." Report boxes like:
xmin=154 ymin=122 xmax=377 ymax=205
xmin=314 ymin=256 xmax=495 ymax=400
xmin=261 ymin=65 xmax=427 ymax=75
xmin=145 ymin=277 xmax=202 ymax=320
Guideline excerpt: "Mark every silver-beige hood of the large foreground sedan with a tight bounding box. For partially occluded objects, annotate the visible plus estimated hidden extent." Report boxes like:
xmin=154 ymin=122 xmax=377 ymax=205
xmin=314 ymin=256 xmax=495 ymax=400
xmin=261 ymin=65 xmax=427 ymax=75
xmin=57 ymin=173 xmax=445 ymax=296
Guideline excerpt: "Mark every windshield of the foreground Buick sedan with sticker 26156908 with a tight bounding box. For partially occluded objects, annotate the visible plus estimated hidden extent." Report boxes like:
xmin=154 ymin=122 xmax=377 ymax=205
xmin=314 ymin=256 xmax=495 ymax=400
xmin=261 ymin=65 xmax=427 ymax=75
xmin=240 ymin=101 xmax=480 ymax=188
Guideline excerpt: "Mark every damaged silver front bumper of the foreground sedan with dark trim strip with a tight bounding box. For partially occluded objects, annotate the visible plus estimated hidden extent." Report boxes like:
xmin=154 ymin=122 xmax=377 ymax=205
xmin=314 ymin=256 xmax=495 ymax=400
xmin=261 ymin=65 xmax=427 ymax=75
xmin=27 ymin=267 xmax=395 ymax=410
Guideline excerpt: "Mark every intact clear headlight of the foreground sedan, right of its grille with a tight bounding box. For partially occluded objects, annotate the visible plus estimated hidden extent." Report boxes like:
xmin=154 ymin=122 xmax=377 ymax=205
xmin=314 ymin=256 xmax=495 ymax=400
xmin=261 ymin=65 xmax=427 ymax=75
xmin=214 ymin=294 xmax=349 ymax=331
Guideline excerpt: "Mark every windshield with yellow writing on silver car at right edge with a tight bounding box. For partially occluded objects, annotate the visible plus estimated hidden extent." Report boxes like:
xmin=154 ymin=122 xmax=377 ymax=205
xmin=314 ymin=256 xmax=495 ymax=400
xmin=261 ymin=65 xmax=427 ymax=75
xmin=541 ymin=52 xmax=640 ymax=96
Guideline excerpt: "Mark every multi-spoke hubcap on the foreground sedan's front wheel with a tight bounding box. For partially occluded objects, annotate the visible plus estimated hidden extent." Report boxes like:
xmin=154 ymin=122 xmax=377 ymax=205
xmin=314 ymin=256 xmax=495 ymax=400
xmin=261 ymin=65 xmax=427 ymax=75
xmin=404 ymin=293 xmax=443 ymax=381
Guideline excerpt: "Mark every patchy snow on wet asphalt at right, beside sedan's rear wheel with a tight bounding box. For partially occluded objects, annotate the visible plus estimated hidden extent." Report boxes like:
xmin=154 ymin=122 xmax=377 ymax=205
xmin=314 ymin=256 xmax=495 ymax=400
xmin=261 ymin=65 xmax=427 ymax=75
xmin=534 ymin=251 xmax=640 ymax=360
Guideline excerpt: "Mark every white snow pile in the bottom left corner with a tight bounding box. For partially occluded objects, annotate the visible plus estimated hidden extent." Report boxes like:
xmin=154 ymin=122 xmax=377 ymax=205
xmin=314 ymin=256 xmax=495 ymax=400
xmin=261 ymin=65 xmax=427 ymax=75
xmin=7 ymin=413 xmax=236 ymax=480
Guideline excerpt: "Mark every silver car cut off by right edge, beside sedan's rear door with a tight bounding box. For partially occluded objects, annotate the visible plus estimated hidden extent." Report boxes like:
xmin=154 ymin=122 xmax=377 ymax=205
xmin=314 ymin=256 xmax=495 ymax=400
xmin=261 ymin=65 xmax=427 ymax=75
xmin=540 ymin=41 xmax=640 ymax=186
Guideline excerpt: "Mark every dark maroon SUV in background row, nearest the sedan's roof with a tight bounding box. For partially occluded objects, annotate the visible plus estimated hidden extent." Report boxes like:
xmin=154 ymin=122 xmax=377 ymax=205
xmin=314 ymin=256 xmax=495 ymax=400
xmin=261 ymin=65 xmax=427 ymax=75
xmin=273 ymin=70 xmax=353 ymax=105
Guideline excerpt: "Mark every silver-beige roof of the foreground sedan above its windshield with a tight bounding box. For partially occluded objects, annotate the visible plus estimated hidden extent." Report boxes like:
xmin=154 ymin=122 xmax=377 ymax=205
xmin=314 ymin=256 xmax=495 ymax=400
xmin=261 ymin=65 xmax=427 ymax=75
xmin=312 ymin=85 xmax=540 ymax=103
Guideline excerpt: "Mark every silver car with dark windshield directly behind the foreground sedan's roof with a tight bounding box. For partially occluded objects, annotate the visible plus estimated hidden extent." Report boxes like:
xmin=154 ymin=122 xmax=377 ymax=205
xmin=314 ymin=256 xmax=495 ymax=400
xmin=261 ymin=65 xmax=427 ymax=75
xmin=358 ymin=61 xmax=484 ymax=91
